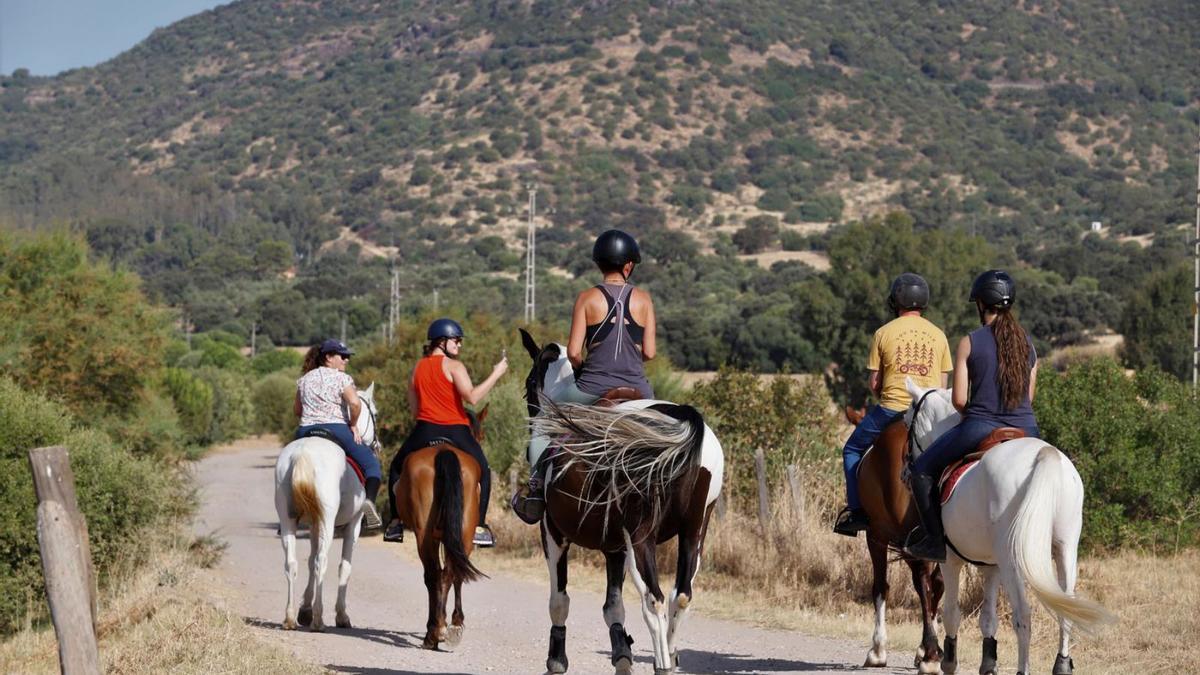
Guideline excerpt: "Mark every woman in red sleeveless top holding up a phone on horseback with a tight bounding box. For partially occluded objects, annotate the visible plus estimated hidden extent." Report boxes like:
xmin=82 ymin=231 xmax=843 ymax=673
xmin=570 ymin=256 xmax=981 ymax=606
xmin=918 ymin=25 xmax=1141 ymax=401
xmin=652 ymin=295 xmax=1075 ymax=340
xmin=384 ymin=318 xmax=509 ymax=548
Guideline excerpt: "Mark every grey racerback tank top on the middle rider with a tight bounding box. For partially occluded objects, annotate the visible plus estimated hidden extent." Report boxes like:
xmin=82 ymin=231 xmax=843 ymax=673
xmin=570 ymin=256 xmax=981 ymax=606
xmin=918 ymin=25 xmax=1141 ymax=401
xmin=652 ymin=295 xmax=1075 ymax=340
xmin=575 ymin=283 xmax=654 ymax=399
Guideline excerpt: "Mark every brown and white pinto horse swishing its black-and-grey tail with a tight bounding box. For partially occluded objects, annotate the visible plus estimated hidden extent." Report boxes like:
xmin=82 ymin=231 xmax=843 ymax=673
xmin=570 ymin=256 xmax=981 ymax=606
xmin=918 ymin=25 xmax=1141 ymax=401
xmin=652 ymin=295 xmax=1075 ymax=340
xmin=521 ymin=330 xmax=725 ymax=675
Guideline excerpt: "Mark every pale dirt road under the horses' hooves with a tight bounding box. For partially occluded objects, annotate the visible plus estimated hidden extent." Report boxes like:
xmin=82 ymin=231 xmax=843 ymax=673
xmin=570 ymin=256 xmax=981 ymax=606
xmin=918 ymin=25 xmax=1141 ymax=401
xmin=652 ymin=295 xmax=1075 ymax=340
xmin=194 ymin=443 xmax=911 ymax=674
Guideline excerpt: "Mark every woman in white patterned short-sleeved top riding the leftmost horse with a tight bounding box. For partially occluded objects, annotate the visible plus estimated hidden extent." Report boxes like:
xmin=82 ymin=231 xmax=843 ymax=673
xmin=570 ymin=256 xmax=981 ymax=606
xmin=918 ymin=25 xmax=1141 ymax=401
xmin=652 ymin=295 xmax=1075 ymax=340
xmin=293 ymin=339 xmax=383 ymax=530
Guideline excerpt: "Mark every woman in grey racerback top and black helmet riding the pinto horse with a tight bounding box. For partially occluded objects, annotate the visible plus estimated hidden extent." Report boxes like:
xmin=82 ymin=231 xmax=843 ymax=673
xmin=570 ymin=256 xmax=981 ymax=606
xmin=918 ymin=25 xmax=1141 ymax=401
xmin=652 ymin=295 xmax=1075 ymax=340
xmin=512 ymin=229 xmax=656 ymax=525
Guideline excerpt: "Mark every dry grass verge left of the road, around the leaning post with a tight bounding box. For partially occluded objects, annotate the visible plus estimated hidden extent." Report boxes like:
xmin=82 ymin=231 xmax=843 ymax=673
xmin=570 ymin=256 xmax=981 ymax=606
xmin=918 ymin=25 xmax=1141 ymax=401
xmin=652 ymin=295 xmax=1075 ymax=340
xmin=0 ymin=533 xmax=325 ymax=675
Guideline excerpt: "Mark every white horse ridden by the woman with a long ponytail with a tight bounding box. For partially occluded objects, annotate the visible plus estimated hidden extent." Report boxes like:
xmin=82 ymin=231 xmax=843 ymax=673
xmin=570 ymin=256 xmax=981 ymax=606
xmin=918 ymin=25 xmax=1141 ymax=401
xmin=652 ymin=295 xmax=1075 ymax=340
xmin=905 ymin=380 xmax=1112 ymax=675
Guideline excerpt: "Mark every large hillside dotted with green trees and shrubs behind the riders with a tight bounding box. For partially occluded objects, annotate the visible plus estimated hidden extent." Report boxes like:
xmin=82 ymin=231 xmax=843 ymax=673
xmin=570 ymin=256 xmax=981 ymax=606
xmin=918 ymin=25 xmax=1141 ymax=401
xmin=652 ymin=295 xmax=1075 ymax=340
xmin=0 ymin=0 xmax=1200 ymax=393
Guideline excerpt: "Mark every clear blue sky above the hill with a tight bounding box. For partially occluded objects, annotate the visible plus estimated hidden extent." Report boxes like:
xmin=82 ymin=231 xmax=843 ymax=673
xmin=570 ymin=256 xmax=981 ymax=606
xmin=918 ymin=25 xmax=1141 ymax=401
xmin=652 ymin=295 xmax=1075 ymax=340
xmin=0 ymin=0 xmax=229 ymax=74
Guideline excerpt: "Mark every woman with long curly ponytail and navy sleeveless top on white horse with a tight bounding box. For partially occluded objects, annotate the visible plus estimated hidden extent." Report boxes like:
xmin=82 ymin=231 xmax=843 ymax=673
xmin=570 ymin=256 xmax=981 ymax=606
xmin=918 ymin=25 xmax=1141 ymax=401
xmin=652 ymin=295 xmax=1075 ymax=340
xmin=904 ymin=269 xmax=1038 ymax=562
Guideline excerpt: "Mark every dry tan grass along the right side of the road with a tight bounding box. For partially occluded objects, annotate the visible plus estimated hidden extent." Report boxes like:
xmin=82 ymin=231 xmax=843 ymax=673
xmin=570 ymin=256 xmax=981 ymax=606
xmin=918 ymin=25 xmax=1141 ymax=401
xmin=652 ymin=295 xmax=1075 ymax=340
xmin=488 ymin=473 xmax=1200 ymax=673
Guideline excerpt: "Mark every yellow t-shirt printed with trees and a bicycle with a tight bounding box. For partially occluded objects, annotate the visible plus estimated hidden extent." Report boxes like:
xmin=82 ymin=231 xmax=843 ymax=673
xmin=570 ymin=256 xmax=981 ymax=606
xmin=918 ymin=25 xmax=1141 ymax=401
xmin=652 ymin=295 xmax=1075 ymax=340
xmin=866 ymin=316 xmax=954 ymax=411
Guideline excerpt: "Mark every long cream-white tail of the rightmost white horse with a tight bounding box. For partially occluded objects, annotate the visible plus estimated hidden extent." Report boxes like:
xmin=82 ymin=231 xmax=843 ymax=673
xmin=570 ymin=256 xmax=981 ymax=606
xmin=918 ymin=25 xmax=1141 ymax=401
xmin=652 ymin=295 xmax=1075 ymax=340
xmin=1008 ymin=446 xmax=1112 ymax=631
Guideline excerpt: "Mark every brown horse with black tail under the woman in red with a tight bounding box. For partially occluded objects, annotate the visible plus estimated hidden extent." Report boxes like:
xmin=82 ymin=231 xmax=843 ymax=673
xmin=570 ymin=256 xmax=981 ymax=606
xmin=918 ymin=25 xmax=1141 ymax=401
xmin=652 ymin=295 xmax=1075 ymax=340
xmin=395 ymin=406 xmax=487 ymax=650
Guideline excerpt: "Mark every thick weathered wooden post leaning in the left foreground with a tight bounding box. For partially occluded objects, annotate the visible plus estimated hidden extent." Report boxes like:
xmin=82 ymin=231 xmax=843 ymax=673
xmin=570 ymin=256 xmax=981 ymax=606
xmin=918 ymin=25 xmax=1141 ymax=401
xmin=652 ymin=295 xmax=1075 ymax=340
xmin=29 ymin=447 xmax=100 ymax=675
